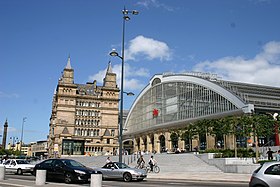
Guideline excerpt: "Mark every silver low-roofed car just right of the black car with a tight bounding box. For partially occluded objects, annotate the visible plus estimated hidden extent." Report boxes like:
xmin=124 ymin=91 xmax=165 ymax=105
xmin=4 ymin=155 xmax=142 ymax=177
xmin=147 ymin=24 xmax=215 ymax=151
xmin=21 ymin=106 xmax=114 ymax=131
xmin=95 ymin=162 xmax=147 ymax=182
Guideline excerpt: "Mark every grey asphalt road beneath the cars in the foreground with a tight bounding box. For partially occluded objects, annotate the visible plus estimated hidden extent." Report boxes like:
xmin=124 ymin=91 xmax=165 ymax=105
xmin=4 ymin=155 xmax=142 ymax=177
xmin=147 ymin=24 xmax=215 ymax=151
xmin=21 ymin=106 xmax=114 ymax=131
xmin=0 ymin=174 xmax=248 ymax=187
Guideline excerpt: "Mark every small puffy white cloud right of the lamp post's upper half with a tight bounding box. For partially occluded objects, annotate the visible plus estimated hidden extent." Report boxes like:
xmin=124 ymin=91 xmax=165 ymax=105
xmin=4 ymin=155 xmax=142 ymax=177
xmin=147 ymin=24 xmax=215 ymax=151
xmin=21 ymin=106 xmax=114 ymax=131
xmin=125 ymin=35 xmax=172 ymax=60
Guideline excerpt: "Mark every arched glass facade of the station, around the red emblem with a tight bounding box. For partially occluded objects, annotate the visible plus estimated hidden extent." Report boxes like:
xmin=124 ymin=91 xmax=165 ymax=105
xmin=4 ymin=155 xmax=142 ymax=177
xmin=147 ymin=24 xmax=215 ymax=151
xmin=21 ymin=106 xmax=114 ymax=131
xmin=127 ymin=82 xmax=237 ymax=133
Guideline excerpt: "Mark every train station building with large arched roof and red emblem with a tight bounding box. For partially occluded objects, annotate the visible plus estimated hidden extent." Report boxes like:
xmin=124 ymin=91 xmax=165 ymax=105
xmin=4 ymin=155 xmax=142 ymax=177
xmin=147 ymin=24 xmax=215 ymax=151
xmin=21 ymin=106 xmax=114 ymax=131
xmin=123 ymin=73 xmax=280 ymax=152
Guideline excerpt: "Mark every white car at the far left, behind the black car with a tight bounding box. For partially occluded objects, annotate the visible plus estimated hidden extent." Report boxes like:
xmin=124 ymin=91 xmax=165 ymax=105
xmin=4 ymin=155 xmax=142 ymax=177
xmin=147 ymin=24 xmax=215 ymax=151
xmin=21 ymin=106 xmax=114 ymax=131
xmin=3 ymin=159 xmax=35 ymax=175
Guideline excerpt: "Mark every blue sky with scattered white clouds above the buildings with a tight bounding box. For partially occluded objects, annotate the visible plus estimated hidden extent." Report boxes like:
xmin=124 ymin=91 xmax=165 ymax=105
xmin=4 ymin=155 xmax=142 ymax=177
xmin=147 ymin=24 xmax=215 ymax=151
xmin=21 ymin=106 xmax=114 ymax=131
xmin=0 ymin=0 xmax=280 ymax=143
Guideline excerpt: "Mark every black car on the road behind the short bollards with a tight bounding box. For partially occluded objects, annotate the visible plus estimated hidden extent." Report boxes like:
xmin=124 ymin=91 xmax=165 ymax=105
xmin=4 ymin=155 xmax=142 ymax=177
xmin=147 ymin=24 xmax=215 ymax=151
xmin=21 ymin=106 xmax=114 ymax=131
xmin=33 ymin=159 xmax=100 ymax=183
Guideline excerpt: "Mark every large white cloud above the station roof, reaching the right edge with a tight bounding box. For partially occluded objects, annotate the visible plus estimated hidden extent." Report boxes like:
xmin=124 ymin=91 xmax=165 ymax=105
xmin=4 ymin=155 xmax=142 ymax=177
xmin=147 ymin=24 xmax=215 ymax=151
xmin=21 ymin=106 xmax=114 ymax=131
xmin=193 ymin=41 xmax=280 ymax=86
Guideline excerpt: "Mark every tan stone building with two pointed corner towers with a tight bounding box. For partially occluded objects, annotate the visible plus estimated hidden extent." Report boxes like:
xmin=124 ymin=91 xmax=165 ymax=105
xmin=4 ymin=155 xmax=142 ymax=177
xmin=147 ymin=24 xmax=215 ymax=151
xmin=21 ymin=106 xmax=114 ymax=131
xmin=48 ymin=57 xmax=119 ymax=157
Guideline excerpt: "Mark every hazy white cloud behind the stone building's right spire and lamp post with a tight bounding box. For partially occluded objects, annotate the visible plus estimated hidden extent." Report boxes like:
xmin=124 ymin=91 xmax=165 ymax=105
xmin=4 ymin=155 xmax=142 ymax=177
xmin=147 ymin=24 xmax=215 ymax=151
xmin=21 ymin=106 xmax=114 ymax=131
xmin=89 ymin=63 xmax=150 ymax=91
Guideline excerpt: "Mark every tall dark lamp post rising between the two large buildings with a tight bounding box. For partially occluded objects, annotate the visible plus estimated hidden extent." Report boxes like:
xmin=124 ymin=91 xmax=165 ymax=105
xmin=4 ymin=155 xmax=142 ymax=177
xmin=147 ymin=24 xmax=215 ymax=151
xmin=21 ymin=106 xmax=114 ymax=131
xmin=110 ymin=7 xmax=139 ymax=162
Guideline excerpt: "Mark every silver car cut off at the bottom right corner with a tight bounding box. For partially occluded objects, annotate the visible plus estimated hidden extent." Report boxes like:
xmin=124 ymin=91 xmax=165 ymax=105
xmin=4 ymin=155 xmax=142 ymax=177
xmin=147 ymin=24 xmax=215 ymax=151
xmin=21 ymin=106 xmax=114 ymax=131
xmin=249 ymin=161 xmax=280 ymax=187
